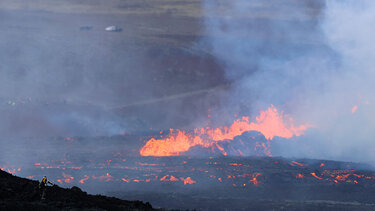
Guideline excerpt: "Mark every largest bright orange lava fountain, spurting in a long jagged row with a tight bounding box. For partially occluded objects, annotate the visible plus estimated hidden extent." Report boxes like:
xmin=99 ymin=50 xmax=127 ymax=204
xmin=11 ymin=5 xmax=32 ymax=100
xmin=140 ymin=106 xmax=308 ymax=156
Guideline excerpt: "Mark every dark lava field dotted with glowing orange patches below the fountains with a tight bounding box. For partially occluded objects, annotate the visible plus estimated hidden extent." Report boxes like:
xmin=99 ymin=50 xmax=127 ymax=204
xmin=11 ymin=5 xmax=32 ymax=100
xmin=1 ymin=132 xmax=375 ymax=210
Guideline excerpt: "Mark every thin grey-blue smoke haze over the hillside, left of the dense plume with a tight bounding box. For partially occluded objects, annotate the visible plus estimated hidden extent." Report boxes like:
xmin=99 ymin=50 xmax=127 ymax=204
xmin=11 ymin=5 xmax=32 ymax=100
xmin=0 ymin=4 xmax=226 ymax=137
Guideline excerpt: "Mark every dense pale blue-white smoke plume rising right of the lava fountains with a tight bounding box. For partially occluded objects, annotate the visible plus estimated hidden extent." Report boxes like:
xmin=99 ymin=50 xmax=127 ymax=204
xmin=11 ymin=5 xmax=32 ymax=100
xmin=204 ymin=0 xmax=375 ymax=162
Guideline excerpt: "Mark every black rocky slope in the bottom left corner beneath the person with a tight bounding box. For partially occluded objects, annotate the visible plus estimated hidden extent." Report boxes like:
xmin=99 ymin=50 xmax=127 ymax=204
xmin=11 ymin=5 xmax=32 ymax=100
xmin=0 ymin=171 xmax=155 ymax=210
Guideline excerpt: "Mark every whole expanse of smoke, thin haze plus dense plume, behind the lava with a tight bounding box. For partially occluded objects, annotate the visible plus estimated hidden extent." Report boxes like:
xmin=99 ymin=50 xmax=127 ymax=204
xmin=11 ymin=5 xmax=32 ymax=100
xmin=0 ymin=0 xmax=375 ymax=162
